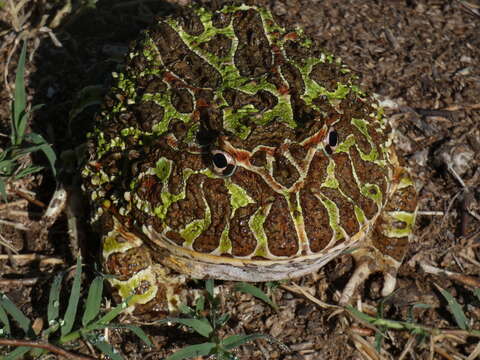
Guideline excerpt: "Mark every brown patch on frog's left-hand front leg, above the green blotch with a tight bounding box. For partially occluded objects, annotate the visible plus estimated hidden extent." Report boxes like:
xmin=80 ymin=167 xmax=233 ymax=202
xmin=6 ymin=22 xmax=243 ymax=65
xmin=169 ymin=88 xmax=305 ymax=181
xmin=104 ymin=246 xmax=152 ymax=280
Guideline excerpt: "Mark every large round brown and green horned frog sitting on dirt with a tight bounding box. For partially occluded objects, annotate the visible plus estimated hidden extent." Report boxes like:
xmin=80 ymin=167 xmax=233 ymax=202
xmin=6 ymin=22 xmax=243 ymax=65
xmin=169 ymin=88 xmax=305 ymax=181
xmin=82 ymin=3 xmax=417 ymax=316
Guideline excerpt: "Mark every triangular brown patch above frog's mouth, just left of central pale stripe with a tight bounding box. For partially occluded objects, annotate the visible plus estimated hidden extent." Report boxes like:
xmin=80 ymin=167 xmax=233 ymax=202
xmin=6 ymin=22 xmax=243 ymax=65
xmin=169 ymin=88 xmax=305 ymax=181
xmin=263 ymin=195 xmax=298 ymax=256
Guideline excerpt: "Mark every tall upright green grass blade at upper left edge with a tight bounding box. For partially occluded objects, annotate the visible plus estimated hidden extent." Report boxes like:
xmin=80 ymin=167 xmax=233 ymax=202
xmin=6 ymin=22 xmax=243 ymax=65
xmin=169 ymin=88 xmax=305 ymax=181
xmin=12 ymin=41 xmax=27 ymax=145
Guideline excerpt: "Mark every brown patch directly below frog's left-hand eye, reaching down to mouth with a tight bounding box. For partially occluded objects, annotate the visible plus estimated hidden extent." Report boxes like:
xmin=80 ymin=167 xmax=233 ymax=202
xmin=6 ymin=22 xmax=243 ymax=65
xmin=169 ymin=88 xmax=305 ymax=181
xmin=193 ymin=179 xmax=231 ymax=253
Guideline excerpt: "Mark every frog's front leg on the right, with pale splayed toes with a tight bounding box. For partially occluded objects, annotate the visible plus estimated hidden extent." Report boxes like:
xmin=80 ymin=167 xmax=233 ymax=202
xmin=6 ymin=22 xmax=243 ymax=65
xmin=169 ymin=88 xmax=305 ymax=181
xmin=340 ymin=166 xmax=417 ymax=305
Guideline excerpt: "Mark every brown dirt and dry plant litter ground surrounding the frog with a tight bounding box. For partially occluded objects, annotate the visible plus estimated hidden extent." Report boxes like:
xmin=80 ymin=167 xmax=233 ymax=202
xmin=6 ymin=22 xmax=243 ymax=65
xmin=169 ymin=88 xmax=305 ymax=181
xmin=0 ymin=0 xmax=480 ymax=360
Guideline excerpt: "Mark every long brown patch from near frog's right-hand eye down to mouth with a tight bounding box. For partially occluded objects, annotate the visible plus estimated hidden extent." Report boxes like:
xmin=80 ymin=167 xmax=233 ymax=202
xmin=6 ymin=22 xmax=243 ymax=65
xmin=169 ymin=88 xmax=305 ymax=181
xmin=300 ymin=153 xmax=333 ymax=252
